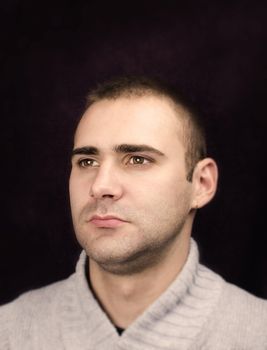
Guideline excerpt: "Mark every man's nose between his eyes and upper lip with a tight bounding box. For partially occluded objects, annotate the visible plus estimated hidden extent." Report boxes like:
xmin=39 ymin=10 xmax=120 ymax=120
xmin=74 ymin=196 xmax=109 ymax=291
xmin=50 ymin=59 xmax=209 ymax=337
xmin=90 ymin=164 xmax=123 ymax=200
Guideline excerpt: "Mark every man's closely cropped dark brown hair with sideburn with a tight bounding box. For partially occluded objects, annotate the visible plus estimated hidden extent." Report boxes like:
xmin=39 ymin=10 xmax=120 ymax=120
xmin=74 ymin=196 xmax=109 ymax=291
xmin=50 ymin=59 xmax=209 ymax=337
xmin=85 ymin=76 xmax=207 ymax=181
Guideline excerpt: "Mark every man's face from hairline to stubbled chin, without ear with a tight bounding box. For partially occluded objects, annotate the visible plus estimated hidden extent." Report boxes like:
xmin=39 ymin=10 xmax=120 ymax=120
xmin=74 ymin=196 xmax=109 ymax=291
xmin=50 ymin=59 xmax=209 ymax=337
xmin=70 ymin=96 xmax=193 ymax=273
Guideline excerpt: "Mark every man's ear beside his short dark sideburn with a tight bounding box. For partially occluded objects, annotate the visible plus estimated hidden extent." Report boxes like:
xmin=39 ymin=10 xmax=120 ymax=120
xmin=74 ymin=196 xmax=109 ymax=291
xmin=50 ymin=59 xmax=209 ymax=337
xmin=192 ymin=158 xmax=218 ymax=209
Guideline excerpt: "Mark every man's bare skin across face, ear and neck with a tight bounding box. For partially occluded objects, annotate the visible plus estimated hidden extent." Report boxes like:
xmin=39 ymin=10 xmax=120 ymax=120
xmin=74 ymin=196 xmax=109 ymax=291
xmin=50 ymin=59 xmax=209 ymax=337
xmin=70 ymin=96 xmax=217 ymax=327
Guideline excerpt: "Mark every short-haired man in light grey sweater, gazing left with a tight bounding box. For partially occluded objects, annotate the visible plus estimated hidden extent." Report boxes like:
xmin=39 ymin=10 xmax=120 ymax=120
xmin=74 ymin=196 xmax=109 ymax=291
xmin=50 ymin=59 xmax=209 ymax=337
xmin=0 ymin=78 xmax=267 ymax=350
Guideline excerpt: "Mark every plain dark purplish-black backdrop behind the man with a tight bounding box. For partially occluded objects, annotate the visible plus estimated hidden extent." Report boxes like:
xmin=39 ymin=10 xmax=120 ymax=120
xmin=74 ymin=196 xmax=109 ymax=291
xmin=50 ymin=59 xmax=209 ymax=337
xmin=0 ymin=0 xmax=267 ymax=303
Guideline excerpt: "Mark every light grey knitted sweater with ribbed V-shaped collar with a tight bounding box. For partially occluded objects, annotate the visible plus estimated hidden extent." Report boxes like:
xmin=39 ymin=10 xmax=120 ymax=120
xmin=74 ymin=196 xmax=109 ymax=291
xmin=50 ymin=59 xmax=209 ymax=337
xmin=0 ymin=240 xmax=267 ymax=350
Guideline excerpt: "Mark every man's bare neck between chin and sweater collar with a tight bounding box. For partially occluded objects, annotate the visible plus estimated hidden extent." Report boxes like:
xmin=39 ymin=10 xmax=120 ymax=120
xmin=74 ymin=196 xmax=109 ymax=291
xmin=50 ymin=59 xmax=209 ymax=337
xmin=89 ymin=235 xmax=190 ymax=328
